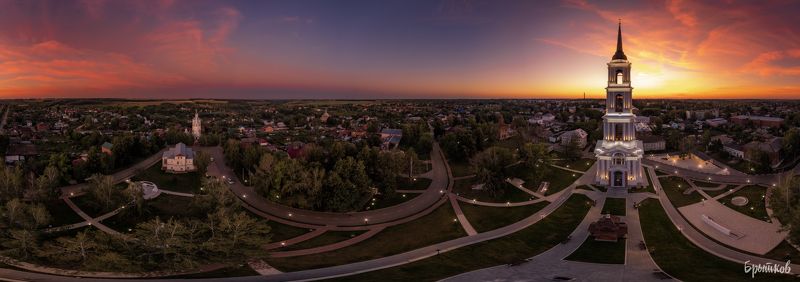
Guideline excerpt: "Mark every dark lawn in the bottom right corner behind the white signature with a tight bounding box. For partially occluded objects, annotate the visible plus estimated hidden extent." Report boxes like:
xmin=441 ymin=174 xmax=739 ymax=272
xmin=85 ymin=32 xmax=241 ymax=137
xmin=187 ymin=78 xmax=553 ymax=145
xmin=639 ymin=199 xmax=797 ymax=281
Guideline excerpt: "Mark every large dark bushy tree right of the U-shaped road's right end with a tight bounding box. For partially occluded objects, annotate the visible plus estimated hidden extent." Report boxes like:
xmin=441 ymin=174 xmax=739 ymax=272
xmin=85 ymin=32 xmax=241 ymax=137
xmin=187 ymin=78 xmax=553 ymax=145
xmin=470 ymin=147 xmax=516 ymax=197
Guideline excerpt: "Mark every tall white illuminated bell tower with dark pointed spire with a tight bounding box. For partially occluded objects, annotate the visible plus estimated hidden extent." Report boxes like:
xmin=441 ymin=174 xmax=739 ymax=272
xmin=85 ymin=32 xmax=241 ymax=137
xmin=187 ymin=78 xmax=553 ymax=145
xmin=594 ymin=25 xmax=647 ymax=188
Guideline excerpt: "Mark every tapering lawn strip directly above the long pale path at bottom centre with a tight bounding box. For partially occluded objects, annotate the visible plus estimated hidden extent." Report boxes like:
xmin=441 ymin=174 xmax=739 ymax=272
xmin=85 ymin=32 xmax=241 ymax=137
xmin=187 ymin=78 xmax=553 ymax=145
xmin=267 ymin=205 xmax=466 ymax=271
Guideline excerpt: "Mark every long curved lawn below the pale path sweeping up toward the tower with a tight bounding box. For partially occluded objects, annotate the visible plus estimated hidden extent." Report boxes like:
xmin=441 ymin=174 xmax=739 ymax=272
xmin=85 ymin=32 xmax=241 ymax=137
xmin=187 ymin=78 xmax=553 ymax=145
xmin=324 ymin=194 xmax=590 ymax=281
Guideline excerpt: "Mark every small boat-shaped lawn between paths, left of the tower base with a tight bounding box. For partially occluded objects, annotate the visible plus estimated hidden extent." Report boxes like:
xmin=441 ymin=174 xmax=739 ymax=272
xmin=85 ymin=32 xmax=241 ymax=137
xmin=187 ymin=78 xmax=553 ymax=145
xmin=458 ymin=201 xmax=549 ymax=232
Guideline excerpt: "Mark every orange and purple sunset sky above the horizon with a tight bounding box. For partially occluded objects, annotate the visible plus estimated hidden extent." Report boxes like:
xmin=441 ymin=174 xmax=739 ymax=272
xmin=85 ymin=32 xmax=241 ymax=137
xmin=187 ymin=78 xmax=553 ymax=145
xmin=0 ymin=0 xmax=800 ymax=99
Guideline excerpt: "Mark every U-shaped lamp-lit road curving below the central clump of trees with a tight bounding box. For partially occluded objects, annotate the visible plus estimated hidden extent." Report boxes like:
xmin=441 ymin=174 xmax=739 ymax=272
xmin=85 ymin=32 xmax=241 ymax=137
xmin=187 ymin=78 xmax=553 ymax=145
xmin=200 ymin=144 xmax=449 ymax=230
